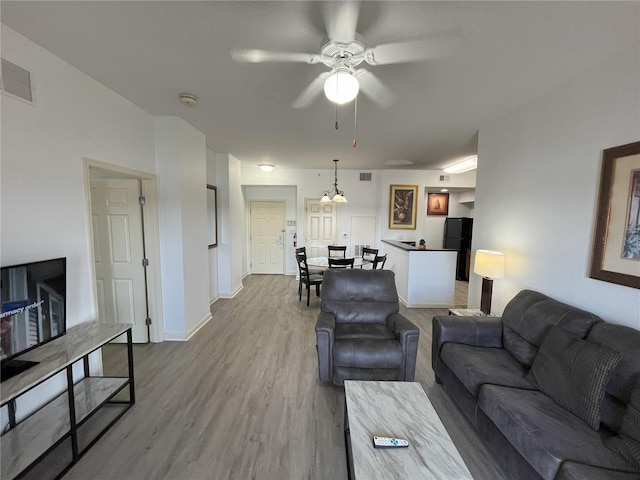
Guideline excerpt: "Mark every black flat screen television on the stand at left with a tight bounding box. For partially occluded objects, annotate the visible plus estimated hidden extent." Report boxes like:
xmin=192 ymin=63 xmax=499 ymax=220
xmin=0 ymin=258 xmax=67 ymax=381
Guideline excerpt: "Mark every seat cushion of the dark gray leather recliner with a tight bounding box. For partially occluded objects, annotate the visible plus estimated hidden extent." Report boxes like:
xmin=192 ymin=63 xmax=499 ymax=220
xmin=333 ymin=338 xmax=404 ymax=368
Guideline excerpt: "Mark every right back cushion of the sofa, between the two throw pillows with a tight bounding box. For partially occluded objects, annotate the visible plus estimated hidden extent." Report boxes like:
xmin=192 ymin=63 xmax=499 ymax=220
xmin=587 ymin=322 xmax=640 ymax=432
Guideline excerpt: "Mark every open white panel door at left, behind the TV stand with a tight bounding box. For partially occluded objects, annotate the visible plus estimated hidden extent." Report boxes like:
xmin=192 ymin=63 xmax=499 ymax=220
xmin=91 ymin=179 xmax=149 ymax=343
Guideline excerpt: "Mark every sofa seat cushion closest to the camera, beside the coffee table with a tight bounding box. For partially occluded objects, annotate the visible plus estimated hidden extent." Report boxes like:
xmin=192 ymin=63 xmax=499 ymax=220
xmin=478 ymin=385 xmax=630 ymax=479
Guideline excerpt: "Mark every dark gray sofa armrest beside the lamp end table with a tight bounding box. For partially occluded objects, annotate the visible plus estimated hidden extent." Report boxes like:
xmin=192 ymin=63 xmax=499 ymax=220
xmin=431 ymin=315 xmax=502 ymax=371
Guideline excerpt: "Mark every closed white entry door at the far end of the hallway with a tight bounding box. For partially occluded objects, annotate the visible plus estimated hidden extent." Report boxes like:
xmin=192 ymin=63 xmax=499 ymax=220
xmin=250 ymin=202 xmax=284 ymax=274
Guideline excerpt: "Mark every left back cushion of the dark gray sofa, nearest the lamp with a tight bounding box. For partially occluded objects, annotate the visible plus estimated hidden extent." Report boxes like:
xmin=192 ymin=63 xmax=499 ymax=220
xmin=502 ymin=290 xmax=602 ymax=367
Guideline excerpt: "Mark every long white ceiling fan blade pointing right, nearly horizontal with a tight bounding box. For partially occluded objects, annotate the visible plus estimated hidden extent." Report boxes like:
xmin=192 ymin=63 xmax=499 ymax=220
xmin=364 ymin=38 xmax=457 ymax=65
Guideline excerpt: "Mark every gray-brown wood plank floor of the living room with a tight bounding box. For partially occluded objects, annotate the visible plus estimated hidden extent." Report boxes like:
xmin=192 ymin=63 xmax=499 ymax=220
xmin=65 ymin=275 xmax=506 ymax=480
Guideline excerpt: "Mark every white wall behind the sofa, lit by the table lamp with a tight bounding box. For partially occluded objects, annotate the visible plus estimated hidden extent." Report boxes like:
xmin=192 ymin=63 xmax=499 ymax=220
xmin=469 ymin=48 xmax=640 ymax=328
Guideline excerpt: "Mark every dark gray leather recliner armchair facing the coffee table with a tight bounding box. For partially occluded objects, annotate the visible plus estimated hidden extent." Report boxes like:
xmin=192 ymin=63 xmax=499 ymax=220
xmin=316 ymin=269 xmax=420 ymax=385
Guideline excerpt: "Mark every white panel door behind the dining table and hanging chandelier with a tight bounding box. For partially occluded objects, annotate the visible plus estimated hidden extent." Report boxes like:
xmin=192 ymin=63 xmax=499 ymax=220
xmin=304 ymin=199 xmax=338 ymax=257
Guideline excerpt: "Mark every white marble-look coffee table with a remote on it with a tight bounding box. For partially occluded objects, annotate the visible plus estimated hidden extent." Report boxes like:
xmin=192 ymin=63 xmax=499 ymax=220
xmin=344 ymin=380 xmax=473 ymax=480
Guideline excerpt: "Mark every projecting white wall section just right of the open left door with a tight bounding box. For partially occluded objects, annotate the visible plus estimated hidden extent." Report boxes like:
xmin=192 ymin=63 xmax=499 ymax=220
xmin=155 ymin=117 xmax=211 ymax=340
